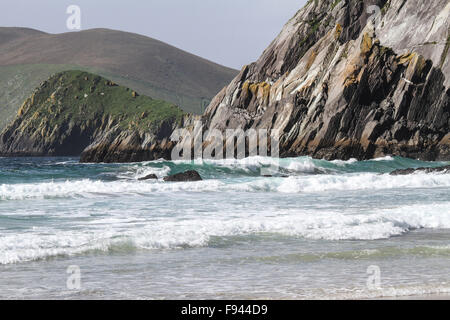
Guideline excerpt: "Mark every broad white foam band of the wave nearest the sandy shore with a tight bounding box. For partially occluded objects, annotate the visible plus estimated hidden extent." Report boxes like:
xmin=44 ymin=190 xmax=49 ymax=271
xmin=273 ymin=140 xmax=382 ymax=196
xmin=0 ymin=202 xmax=450 ymax=264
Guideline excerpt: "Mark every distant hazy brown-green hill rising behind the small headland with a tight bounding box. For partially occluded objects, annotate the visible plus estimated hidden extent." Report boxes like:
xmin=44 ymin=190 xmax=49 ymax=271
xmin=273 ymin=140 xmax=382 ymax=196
xmin=0 ymin=28 xmax=237 ymax=129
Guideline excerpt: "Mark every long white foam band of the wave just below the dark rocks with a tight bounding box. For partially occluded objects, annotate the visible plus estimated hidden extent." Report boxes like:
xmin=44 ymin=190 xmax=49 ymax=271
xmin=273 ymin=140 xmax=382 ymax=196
xmin=0 ymin=169 xmax=450 ymax=200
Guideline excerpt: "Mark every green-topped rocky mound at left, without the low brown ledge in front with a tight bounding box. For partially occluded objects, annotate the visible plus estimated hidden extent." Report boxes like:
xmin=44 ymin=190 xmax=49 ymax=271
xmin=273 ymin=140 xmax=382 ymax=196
xmin=0 ymin=71 xmax=184 ymax=156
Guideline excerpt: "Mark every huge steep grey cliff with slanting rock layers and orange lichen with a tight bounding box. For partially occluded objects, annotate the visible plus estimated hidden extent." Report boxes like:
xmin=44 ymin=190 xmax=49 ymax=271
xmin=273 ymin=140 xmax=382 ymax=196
xmin=203 ymin=0 xmax=450 ymax=160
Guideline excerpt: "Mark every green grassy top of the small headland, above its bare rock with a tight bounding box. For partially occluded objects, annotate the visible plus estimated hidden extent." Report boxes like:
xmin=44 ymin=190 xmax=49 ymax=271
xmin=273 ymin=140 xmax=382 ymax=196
xmin=18 ymin=71 xmax=183 ymax=132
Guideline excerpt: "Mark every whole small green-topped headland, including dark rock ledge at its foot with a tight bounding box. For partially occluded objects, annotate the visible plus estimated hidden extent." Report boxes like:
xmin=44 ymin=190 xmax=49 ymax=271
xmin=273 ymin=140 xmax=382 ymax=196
xmin=0 ymin=71 xmax=184 ymax=162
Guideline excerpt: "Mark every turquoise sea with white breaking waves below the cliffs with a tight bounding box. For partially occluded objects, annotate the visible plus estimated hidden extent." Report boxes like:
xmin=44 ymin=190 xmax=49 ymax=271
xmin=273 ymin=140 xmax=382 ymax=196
xmin=0 ymin=157 xmax=450 ymax=299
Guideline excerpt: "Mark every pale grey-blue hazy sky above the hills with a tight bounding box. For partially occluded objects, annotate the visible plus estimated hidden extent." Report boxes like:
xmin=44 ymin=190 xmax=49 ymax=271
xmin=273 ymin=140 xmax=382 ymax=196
xmin=0 ymin=0 xmax=306 ymax=69
